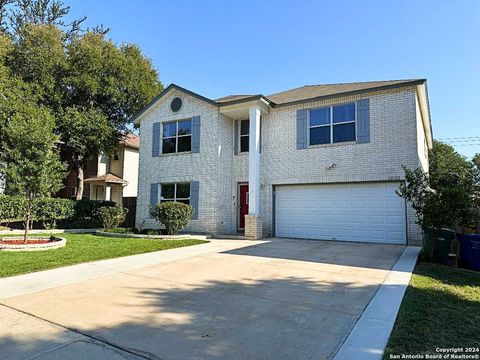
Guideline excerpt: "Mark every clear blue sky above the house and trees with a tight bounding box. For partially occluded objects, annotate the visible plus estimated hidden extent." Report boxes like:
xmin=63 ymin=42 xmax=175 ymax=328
xmin=64 ymin=0 xmax=480 ymax=157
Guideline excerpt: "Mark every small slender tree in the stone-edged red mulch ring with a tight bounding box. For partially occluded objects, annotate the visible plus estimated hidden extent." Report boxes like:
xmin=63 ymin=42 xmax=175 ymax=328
xmin=0 ymin=103 xmax=66 ymax=241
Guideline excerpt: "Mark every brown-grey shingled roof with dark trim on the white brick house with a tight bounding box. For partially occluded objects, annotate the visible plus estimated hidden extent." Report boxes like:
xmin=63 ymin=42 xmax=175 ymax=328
xmin=132 ymin=79 xmax=426 ymax=121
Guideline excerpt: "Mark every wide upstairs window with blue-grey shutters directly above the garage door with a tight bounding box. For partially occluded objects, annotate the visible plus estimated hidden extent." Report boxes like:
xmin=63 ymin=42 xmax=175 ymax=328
xmin=309 ymin=103 xmax=356 ymax=145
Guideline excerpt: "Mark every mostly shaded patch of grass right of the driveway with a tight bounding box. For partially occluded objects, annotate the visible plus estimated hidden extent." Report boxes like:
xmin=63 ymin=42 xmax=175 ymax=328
xmin=384 ymin=263 xmax=480 ymax=359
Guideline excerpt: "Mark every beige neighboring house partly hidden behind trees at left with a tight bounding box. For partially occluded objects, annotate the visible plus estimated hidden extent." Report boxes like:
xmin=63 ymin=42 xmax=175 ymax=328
xmin=85 ymin=134 xmax=140 ymax=205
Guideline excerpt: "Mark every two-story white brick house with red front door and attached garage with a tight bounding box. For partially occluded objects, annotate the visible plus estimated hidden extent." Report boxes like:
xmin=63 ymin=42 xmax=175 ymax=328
xmin=134 ymin=79 xmax=432 ymax=244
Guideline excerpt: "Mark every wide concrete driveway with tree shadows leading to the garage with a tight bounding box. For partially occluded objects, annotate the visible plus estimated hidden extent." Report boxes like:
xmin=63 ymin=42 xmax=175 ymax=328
xmin=0 ymin=239 xmax=404 ymax=360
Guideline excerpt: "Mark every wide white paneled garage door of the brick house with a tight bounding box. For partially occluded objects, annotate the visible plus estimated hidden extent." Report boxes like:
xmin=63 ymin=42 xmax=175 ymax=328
xmin=275 ymin=183 xmax=406 ymax=244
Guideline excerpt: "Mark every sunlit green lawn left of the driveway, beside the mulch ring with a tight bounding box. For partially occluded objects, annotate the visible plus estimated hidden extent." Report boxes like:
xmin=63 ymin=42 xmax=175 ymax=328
xmin=0 ymin=234 xmax=208 ymax=277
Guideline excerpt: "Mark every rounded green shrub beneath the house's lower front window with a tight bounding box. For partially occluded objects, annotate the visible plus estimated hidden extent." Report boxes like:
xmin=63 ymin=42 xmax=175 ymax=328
xmin=150 ymin=201 xmax=193 ymax=235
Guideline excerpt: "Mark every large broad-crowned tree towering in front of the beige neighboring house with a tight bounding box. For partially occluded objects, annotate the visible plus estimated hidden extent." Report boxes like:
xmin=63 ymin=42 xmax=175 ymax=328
xmin=1 ymin=14 xmax=163 ymax=199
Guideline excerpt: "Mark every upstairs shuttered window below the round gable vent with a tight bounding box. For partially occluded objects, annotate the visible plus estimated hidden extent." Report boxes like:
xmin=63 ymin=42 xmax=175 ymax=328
xmin=162 ymin=119 xmax=192 ymax=154
